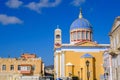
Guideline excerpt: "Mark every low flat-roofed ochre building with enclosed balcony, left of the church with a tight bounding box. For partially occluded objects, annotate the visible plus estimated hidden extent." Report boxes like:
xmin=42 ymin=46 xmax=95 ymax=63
xmin=0 ymin=53 xmax=44 ymax=80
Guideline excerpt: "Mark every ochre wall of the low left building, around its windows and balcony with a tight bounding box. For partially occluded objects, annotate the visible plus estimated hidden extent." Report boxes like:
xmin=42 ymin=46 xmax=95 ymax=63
xmin=0 ymin=58 xmax=44 ymax=80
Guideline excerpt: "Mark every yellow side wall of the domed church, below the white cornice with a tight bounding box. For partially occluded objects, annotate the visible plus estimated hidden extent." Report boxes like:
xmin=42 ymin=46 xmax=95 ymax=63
xmin=64 ymin=51 xmax=104 ymax=80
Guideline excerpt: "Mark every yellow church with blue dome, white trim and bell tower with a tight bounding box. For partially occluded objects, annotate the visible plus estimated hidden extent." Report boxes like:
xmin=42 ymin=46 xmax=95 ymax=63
xmin=54 ymin=10 xmax=110 ymax=80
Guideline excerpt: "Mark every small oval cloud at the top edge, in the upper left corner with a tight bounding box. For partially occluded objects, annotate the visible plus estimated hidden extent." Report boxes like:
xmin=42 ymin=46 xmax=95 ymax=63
xmin=6 ymin=0 xmax=23 ymax=8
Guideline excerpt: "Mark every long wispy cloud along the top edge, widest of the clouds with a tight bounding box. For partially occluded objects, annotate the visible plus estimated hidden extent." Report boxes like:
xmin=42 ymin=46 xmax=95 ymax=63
xmin=26 ymin=0 xmax=61 ymax=13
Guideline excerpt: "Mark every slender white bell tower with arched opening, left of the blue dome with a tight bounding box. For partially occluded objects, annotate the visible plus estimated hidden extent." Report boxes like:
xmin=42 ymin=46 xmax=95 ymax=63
xmin=54 ymin=25 xmax=62 ymax=48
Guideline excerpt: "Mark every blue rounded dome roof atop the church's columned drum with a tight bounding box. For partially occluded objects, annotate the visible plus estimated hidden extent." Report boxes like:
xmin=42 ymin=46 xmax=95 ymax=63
xmin=70 ymin=18 xmax=92 ymax=30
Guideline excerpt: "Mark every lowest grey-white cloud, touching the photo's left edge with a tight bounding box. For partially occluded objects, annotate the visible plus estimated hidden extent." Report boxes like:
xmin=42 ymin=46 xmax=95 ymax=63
xmin=0 ymin=14 xmax=22 ymax=25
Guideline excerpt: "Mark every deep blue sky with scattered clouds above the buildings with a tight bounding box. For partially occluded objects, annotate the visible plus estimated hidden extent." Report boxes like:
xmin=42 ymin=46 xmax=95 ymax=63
xmin=0 ymin=0 xmax=120 ymax=65
